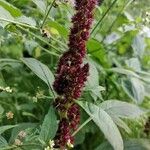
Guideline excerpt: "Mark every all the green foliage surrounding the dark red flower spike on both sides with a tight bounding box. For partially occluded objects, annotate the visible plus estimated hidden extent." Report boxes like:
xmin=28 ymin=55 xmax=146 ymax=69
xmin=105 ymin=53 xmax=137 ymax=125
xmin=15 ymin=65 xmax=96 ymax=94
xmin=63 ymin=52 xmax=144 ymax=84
xmin=0 ymin=0 xmax=150 ymax=150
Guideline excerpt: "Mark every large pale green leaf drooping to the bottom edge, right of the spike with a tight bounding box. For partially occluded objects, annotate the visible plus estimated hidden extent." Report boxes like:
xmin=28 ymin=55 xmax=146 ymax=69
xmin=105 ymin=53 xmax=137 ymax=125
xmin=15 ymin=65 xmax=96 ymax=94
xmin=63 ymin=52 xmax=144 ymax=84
xmin=77 ymin=101 xmax=123 ymax=150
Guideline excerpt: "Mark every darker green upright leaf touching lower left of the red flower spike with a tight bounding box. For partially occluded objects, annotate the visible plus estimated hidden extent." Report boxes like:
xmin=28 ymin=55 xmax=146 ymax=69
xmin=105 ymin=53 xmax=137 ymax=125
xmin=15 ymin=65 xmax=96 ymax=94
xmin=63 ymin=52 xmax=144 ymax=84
xmin=39 ymin=107 xmax=58 ymax=143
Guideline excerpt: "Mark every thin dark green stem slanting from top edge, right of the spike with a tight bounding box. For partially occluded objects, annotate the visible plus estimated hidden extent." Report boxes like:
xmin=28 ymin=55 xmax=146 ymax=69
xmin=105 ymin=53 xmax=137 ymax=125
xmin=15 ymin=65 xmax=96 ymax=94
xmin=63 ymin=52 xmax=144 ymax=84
xmin=91 ymin=0 xmax=117 ymax=35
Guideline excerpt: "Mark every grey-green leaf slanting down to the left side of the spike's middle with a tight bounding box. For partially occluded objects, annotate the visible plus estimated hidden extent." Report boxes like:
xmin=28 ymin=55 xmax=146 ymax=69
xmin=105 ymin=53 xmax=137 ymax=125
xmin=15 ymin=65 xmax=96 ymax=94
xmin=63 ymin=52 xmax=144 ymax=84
xmin=21 ymin=58 xmax=54 ymax=89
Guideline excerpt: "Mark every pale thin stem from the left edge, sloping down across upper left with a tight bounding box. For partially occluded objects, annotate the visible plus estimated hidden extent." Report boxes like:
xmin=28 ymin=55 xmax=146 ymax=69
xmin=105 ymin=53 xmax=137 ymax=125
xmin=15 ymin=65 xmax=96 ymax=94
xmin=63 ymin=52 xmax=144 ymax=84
xmin=0 ymin=17 xmax=38 ymax=30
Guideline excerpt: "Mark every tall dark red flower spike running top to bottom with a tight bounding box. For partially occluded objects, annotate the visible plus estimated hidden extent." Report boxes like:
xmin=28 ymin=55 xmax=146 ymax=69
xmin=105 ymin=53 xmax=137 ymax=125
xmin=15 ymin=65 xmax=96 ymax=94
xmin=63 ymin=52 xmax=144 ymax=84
xmin=53 ymin=0 xmax=97 ymax=149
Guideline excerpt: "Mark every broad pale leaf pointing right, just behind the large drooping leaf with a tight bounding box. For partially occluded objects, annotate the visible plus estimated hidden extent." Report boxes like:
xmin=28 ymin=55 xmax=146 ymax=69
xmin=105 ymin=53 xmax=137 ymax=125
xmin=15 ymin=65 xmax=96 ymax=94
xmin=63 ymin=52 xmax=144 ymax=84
xmin=100 ymin=100 xmax=145 ymax=118
